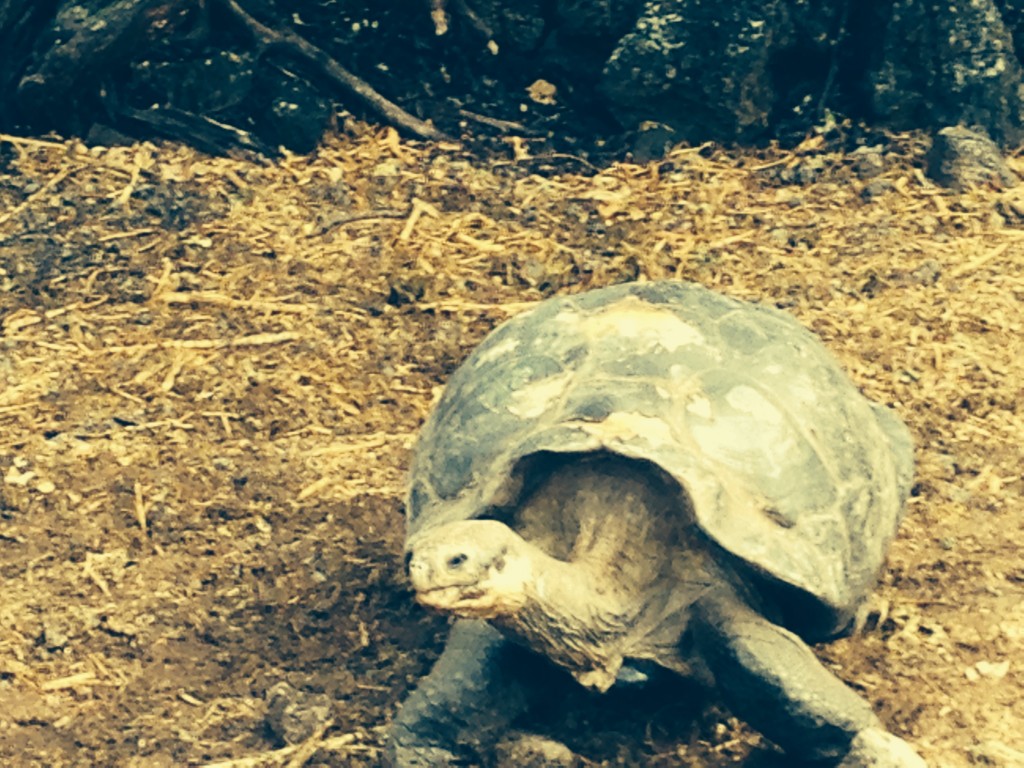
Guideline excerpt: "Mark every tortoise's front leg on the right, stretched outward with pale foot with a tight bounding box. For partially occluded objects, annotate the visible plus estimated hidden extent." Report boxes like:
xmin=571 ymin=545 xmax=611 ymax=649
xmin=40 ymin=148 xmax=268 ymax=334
xmin=691 ymin=589 xmax=927 ymax=768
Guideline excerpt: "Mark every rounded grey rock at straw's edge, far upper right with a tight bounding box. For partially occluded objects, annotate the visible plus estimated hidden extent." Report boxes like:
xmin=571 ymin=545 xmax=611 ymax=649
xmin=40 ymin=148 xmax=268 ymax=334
xmin=928 ymin=126 xmax=1020 ymax=189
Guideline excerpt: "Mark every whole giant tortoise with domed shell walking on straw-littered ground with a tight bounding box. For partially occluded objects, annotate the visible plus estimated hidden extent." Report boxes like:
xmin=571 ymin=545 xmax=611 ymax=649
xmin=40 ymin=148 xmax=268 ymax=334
xmin=388 ymin=282 xmax=925 ymax=768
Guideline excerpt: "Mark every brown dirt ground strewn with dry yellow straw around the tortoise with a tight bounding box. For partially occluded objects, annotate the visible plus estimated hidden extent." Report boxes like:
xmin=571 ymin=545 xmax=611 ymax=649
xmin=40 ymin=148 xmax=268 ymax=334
xmin=0 ymin=125 xmax=1024 ymax=768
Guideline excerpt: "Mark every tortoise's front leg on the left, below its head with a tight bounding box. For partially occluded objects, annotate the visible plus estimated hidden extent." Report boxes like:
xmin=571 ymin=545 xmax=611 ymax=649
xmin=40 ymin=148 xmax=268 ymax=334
xmin=387 ymin=620 xmax=544 ymax=768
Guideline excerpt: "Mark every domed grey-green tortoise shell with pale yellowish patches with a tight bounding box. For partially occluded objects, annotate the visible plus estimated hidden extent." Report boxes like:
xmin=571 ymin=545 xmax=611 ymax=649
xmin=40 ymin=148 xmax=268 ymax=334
xmin=407 ymin=282 xmax=913 ymax=615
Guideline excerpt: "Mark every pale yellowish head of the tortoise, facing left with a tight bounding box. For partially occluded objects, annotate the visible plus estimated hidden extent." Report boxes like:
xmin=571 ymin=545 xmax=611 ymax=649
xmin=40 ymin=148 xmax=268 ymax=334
xmin=406 ymin=520 xmax=532 ymax=618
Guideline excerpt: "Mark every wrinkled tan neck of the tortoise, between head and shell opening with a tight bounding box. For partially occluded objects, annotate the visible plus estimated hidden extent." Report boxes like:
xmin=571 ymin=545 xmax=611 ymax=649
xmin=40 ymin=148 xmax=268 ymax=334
xmin=494 ymin=455 xmax=729 ymax=690
